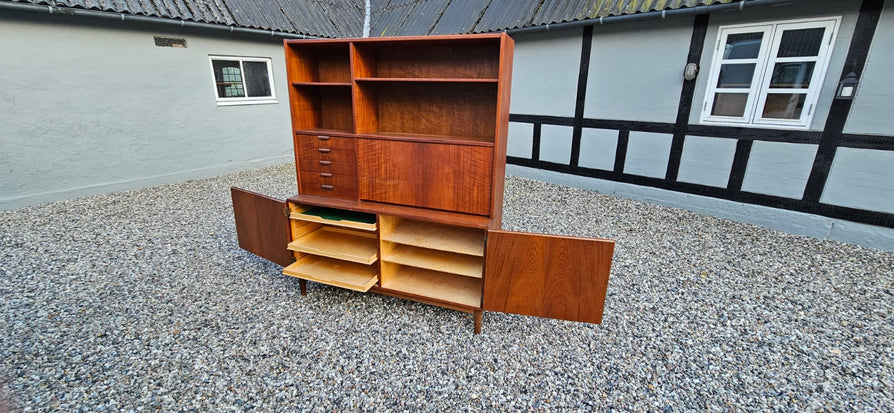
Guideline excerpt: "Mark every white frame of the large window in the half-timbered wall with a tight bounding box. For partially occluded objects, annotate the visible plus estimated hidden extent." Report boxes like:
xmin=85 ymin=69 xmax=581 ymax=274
xmin=700 ymin=17 xmax=841 ymax=129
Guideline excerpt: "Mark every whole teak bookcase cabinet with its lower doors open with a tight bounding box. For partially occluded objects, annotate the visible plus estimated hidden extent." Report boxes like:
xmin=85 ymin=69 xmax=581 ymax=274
xmin=231 ymin=34 xmax=614 ymax=333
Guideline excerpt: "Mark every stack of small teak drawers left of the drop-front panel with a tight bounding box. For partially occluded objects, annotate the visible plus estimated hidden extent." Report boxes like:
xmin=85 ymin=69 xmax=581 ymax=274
xmin=296 ymin=135 xmax=357 ymax=199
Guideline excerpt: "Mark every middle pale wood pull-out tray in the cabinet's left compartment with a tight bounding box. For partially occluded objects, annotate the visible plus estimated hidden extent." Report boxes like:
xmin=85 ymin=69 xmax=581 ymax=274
xmin=288 ymin=227 xmax=378 ymax=265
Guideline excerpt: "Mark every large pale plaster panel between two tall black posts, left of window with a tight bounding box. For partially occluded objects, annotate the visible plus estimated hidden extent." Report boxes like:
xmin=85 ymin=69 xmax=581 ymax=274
xmin=584 ymin=17 xmax=693 ymax=123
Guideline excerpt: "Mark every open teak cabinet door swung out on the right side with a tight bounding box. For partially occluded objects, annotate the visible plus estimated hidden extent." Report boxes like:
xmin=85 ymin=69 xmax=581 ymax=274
xmin=483 ymin=231 xmax=615 ymax=324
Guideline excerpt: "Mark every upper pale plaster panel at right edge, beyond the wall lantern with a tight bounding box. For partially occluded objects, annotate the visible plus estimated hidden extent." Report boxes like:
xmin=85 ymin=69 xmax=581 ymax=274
xmin=844 ymin=1 xmax=894 ymax=134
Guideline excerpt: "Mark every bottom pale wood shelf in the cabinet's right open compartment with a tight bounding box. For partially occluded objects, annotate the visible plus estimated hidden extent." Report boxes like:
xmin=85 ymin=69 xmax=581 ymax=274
xmin=382 ymin=266 xmax=481 ymax=308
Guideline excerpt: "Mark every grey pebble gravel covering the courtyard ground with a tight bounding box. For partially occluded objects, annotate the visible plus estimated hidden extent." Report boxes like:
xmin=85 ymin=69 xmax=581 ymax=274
xmin=0 ymin=165 xmax=894 ymax=412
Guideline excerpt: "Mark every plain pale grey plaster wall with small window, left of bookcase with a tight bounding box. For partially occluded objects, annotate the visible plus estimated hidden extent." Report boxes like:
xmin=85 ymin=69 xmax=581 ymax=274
xmin=0 ymin=14 xmax=292 ymax=209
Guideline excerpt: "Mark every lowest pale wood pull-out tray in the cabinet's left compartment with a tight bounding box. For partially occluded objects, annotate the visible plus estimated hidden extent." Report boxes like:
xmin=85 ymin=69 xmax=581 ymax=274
xmin=282 ymin=255 xmax=378 ymax=292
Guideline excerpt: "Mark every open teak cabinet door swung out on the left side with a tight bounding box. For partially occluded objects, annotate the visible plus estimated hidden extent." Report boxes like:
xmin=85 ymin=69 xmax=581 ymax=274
xmin=230 ymin=188 xmax=293 ymax=267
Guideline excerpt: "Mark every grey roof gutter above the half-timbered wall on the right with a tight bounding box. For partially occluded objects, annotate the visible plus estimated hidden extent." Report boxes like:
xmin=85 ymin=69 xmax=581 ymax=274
xmin=506 ymin=0 xmax=797 ymax=35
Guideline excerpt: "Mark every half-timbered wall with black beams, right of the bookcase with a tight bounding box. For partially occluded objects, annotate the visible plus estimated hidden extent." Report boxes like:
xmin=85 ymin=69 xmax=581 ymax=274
xmin=508 ymin=0 xmax=894 ymax=250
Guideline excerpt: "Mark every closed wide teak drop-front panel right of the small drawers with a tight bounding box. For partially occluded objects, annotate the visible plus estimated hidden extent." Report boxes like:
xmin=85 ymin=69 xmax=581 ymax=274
xmin=357 ymin=139 xmax=493 ymax=215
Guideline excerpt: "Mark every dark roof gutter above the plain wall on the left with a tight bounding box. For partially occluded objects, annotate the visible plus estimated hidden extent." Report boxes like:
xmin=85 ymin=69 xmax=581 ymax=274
xmin=0 ymin=1 xmax=316 ymax=39
